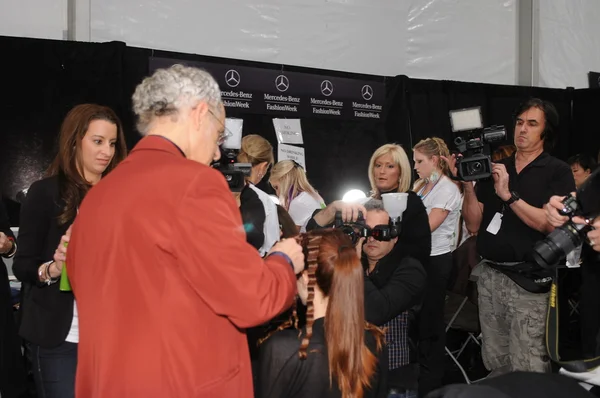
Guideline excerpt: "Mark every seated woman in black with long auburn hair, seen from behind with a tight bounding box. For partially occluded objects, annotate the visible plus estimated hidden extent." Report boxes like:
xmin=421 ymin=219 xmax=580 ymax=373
xmin=257 ymin=229 xmax=388 ymax=398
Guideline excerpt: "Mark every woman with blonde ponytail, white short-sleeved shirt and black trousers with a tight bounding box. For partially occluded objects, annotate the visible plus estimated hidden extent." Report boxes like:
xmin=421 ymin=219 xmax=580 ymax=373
xmin=413 ymin=137 xmax=461 ymax=396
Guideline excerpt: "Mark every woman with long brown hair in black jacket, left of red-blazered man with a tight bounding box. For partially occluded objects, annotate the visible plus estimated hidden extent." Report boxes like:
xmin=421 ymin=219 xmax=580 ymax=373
xmin=13 ymin=104 xmax=127 ymax=398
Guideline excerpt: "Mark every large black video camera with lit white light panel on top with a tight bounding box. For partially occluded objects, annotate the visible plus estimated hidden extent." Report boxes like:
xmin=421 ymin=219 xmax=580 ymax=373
xmin=450 ymin=107 xmax=506 ymax=181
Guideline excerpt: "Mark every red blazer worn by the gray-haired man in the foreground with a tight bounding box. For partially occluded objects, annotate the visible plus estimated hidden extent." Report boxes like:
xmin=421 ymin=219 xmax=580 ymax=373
xmin=67 ymin=136 xmax=296 ymax=398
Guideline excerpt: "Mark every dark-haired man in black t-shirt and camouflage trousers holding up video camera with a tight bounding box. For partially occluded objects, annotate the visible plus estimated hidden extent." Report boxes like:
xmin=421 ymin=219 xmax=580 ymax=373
xmin=448 ymin=99 xmax=575 ymax=375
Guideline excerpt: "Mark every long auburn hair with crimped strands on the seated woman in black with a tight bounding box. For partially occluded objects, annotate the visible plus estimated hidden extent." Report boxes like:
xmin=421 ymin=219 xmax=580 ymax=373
xmin=262 ymin=229 xmax=383 ymax=398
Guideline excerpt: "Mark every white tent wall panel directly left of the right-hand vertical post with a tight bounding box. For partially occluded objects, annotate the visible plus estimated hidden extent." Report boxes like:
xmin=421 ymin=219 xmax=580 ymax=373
xmin=406 ymin=0 xmax=517 ymax=84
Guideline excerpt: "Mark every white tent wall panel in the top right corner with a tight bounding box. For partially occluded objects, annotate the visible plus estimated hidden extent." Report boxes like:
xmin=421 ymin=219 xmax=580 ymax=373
xmin=539 ymin=0 xmax=600 ymax=88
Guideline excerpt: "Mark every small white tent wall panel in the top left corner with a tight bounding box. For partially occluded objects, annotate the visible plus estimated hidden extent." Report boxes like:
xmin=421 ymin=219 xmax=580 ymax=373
xmin=0 ymin=0 xmax=67 ymax=40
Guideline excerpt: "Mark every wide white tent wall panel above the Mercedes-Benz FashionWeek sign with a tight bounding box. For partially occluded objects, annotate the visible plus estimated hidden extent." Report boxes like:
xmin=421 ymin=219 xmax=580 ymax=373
xmin=91 ymin=0 xmax=408 ymax=74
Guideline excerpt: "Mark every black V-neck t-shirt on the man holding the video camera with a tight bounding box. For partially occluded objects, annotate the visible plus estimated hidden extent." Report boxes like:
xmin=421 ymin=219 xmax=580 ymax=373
xmin=476 ymin=152 xmax=575 ymax=293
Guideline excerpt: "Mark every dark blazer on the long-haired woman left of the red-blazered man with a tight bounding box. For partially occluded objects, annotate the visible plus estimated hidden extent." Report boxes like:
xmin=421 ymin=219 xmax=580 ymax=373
xmin=13 ymin=177 xmax=73 ymax=348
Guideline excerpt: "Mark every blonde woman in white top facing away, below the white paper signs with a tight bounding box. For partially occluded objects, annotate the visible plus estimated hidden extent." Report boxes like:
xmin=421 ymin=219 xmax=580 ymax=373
xmin=269 ymin=160 xmax=325 ymax=232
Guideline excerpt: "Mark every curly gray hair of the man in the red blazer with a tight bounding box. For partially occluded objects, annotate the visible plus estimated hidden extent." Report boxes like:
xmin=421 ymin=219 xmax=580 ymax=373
xmin=132 ymin=64 xmax=221 ymax=134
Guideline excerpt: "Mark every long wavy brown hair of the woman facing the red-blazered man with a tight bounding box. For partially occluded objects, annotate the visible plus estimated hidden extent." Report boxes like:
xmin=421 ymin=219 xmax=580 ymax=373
xmin=46 ymin=104 xmax=127 ymax=225
